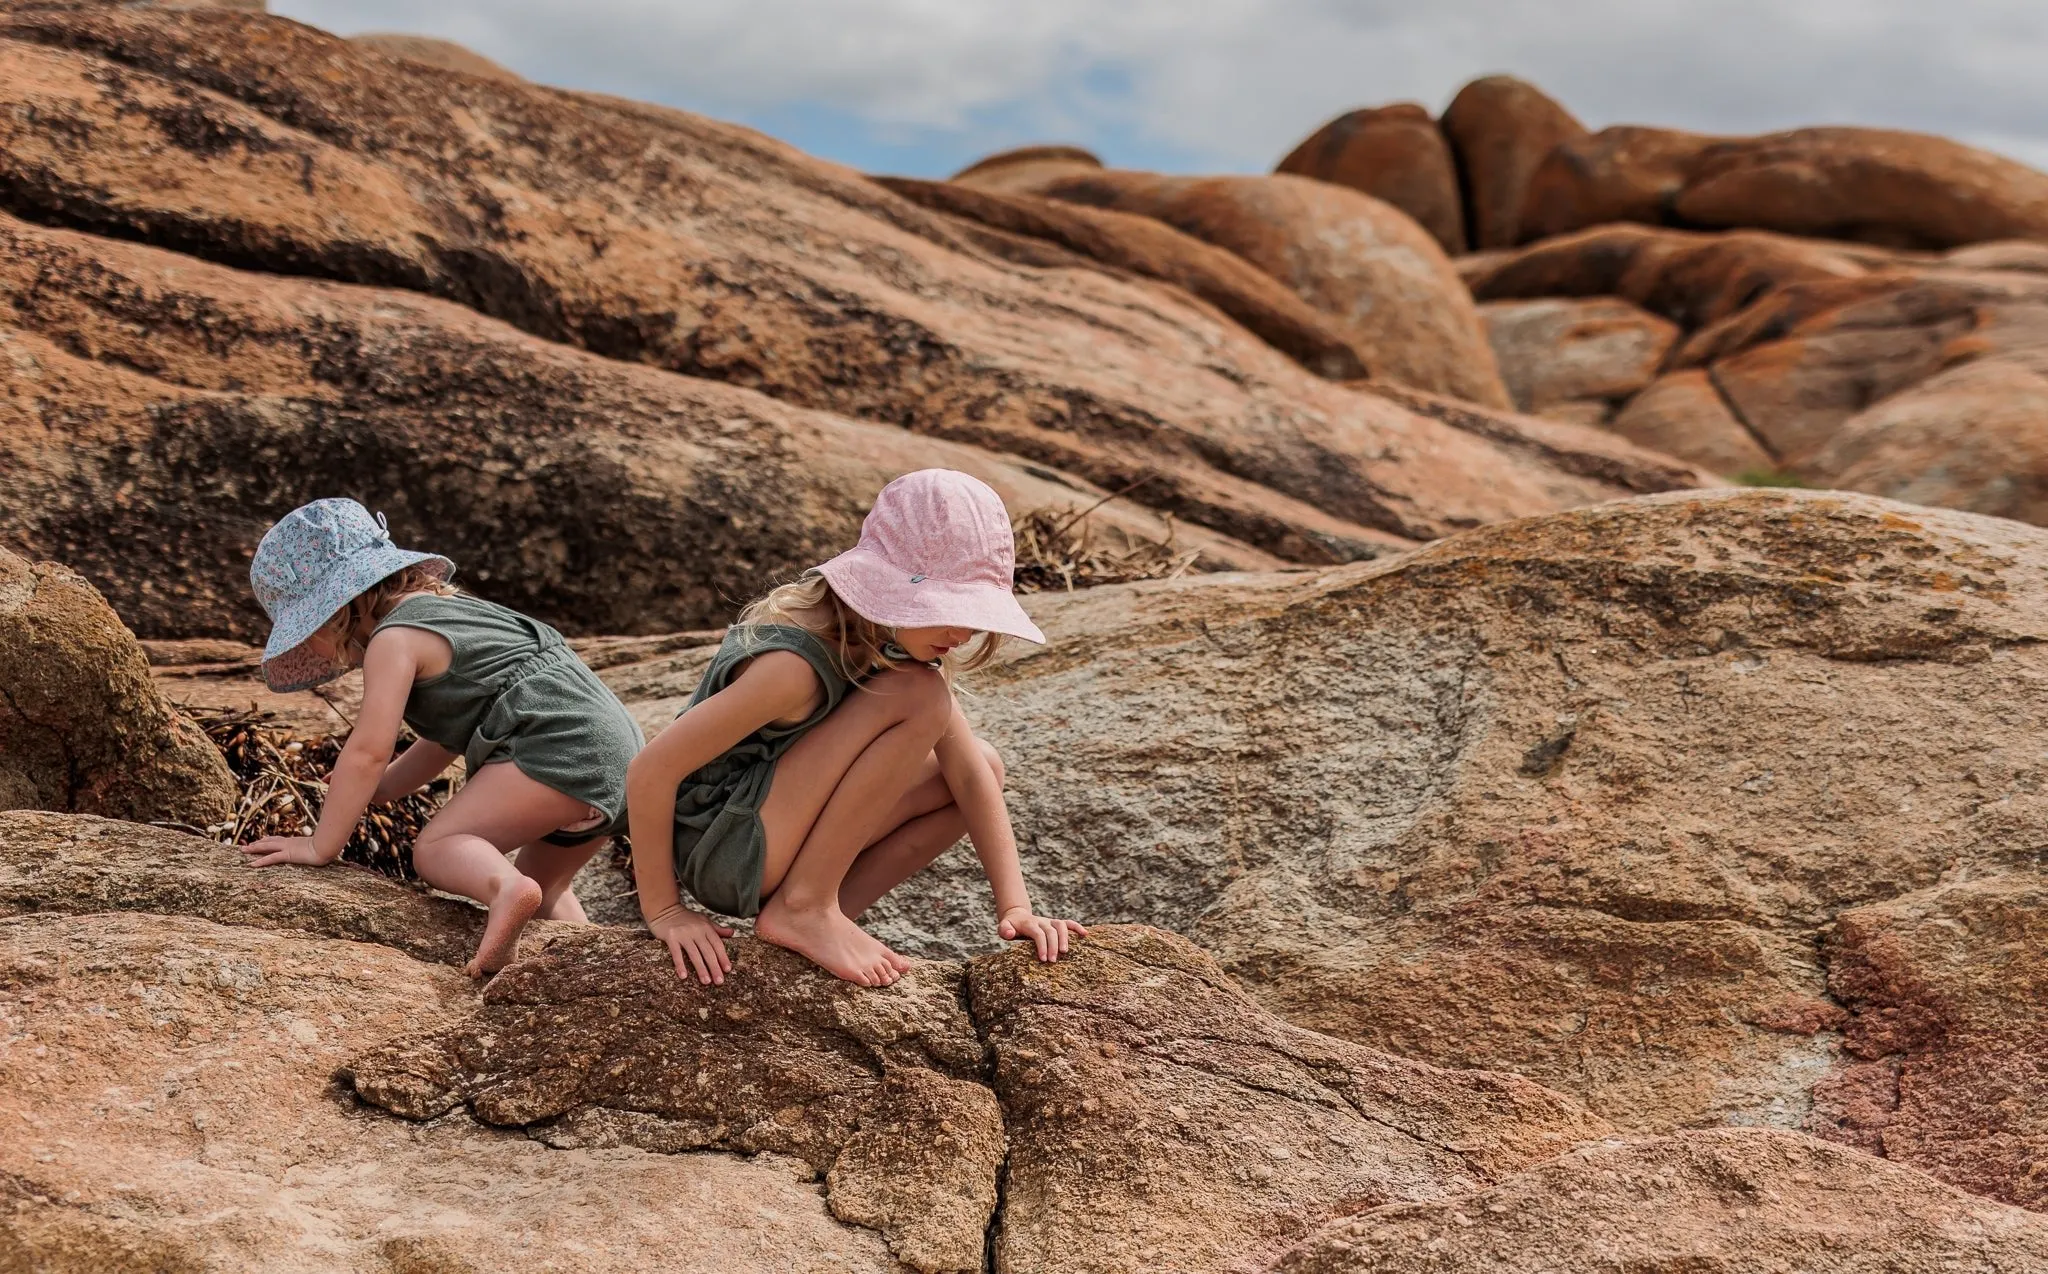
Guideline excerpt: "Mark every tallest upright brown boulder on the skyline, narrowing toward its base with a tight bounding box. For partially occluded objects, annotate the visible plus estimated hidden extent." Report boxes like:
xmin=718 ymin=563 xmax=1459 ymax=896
xmin=1442 ymin=76 xmax=1587 ymax=250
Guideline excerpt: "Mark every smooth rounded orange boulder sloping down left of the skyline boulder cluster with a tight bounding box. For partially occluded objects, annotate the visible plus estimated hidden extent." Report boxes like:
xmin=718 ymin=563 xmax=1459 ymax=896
xmin=1042 ymin=170 xmax=1507 ymax=408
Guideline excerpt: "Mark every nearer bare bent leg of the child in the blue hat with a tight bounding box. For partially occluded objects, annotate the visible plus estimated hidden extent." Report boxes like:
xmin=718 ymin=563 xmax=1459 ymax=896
xmin=412 ymin=764 xmax=586 ymax=977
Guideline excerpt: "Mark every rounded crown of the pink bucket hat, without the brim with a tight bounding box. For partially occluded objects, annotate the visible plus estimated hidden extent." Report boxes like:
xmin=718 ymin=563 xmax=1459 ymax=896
xmin=860 ymin=469 xmax=1016 ymax=590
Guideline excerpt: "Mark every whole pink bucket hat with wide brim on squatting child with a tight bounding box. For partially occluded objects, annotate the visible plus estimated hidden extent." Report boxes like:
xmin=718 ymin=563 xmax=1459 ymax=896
xmin=817 ymin=469 xmax=1044 ymax=643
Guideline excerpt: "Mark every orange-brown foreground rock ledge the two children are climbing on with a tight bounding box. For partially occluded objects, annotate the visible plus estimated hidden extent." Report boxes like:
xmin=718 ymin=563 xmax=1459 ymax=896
xmin=0 ymin=813 xmax=2048 ymax=1274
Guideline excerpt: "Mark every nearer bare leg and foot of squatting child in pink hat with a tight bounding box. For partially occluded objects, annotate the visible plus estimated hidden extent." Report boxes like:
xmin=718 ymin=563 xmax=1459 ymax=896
xmin=754 ymin=668 xmax=952 ymax=985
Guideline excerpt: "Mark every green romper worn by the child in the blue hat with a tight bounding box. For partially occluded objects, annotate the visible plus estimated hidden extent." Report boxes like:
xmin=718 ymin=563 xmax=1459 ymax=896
xmin=377 ymin=594 xmax=647 ymax=846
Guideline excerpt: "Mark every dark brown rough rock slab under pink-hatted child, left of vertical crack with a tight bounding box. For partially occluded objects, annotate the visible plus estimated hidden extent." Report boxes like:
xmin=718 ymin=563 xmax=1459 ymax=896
xmin=348 ymin=930 xmax=1004 ymax=1274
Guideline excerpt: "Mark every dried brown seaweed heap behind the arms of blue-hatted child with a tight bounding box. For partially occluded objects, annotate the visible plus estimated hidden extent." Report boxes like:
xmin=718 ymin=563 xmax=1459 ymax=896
xmin=184 ymin=707 xmax=455 ymax=881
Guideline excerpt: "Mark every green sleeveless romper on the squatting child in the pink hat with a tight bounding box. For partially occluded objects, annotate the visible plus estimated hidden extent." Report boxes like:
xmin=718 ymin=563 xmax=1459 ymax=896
xmin=676 ymin=625 xmax=854 ymax=916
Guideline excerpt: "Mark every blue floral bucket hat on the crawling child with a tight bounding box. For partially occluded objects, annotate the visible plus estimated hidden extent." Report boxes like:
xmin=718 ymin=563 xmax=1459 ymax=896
xmin=250 ymin=500 xmax=455 ymax=690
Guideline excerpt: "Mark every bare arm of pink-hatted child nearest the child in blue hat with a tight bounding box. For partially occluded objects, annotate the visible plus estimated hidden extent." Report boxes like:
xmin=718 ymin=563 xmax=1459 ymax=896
xmin=627 ymin=651 xmax=817 ymax=985
